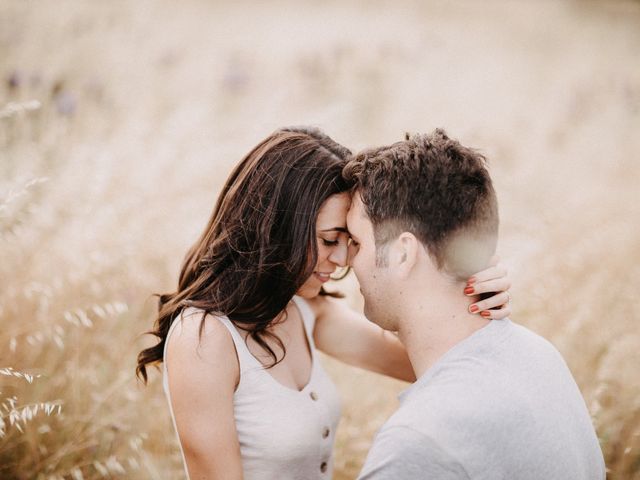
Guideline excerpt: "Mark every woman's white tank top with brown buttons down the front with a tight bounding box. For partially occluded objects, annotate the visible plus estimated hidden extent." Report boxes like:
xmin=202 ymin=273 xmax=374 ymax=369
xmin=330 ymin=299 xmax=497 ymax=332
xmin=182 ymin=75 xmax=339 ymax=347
xmin=162 ymin=297 xmax=340 ymax=480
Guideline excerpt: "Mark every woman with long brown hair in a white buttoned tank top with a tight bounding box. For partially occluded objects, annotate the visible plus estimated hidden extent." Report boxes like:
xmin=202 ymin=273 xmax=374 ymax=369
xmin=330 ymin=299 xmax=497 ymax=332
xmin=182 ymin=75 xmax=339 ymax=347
xmin=137 ymin=128 xmax=509 ymax=480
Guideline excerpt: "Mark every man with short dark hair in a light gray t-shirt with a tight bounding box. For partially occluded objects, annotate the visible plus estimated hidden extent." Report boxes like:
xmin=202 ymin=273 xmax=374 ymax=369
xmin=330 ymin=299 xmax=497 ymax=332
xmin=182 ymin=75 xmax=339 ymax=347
xmin=344 ymin=130 xmax=605 ymax=480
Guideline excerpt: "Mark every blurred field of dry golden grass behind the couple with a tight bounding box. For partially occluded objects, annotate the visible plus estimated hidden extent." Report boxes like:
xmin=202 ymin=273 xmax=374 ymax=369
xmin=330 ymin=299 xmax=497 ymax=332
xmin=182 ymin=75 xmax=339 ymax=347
xmin=0 ymin=0 xmax=640 ymax=480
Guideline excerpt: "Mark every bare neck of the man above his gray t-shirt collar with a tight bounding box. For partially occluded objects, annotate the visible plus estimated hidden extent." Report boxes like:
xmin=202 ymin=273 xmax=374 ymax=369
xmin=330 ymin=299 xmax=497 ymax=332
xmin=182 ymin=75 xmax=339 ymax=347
xmin=398 ymin=286 xmax=490 ymax=378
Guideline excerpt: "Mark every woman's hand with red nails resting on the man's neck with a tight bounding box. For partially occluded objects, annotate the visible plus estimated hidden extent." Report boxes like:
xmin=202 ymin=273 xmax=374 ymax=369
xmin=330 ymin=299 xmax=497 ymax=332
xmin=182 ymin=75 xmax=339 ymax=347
xmin=464 ymin=259 xmax=511 ymax=320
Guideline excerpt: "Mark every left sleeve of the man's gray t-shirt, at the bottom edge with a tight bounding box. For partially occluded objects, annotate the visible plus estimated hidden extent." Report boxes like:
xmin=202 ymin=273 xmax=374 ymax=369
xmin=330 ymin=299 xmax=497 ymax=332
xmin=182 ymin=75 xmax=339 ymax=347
xmin=358 ymin=426 xmax=469 ymax=480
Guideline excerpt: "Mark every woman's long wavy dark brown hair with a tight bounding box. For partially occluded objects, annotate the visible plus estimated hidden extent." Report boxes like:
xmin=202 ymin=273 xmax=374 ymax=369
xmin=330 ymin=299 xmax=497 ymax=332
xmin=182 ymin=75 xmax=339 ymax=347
xmin=136 ymin=127 xmax=351 ymax=383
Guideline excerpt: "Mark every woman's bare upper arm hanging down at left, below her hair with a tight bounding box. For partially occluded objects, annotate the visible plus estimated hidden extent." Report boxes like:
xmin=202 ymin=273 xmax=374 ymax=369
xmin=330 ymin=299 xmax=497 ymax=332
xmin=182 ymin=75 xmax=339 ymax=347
xmin=166 ymin=314 xmax=242 ymax=480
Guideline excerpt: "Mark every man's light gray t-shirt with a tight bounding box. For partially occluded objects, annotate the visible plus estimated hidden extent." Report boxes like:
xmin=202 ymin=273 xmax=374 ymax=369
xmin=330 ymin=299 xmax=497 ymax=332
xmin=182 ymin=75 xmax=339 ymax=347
xmin=359 ymin=320 xmax=605 ymax=480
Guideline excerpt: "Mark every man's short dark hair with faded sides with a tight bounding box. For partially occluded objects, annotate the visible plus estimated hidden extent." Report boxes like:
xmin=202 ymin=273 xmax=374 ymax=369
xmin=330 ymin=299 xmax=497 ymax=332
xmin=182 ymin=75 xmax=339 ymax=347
xmin=343 ymin=129 xmax=498 ymax=276
